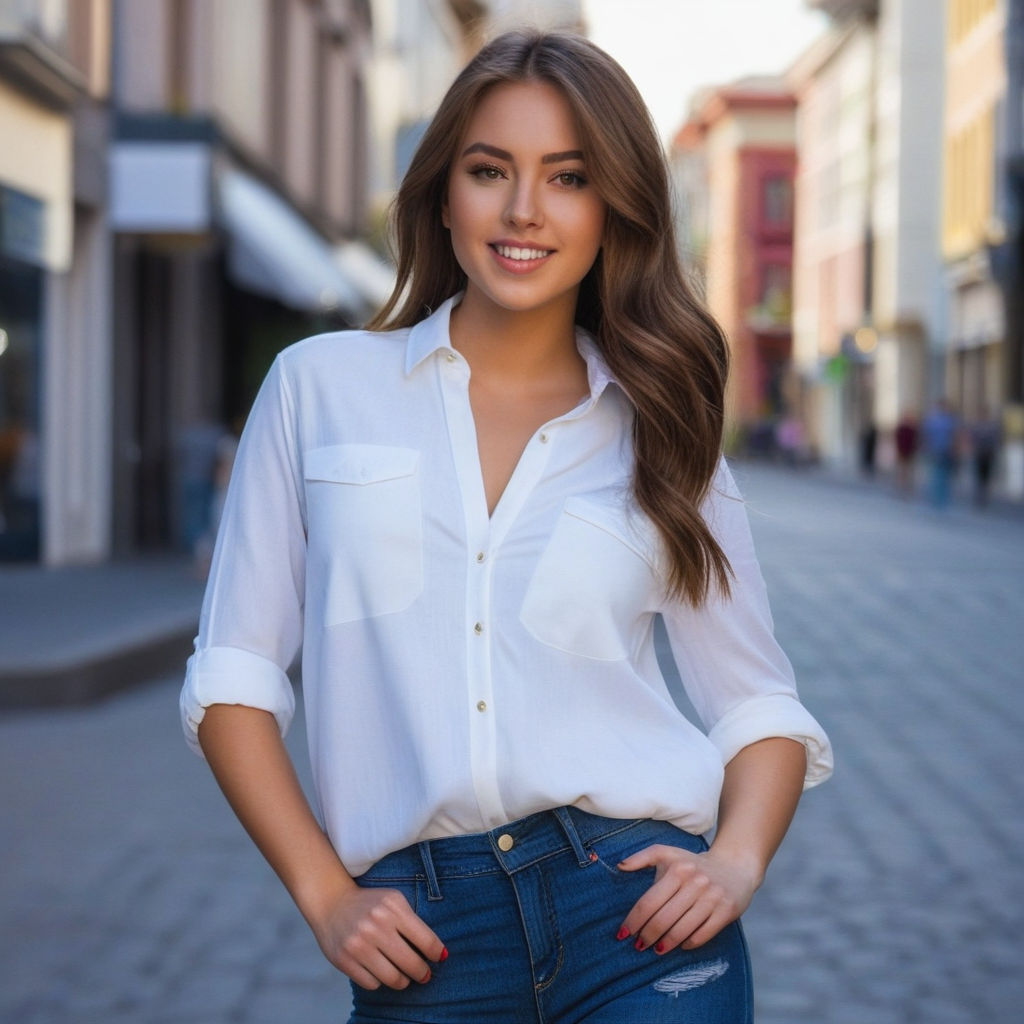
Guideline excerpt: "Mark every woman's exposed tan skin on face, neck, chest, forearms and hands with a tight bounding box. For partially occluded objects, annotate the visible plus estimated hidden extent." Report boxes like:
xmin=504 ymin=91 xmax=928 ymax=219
xmin=199 ymin=83 xmax=806 ymax=989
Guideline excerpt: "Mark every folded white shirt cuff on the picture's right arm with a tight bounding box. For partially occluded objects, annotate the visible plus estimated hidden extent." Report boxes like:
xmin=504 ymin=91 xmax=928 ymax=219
xmin=708 ymin=693 xmax=833 ymax=790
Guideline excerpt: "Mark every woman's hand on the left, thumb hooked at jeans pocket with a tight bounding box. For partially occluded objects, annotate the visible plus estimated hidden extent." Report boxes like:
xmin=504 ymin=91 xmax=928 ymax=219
xmin=312 ymin=884 xmax=447 ymax=989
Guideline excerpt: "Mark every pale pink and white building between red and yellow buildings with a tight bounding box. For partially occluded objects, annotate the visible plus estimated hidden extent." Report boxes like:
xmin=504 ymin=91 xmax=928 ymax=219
xmin=790 ymin=0 xmax=945 ymax=469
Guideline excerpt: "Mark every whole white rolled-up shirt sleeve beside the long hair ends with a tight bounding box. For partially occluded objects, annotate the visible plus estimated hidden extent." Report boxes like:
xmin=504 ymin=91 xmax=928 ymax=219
xmin=663 ymin=460 xmax=833 ymax=788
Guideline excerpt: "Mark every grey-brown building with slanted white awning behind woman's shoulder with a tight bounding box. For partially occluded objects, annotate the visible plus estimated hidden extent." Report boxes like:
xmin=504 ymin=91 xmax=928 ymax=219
xmin=111 ymin=0 xmax=380 ymax=554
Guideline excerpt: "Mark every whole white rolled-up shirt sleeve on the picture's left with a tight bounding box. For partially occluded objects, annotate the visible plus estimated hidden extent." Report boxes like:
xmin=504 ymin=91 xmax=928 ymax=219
xmin=180 ymin=357 xmax=305 ymax=755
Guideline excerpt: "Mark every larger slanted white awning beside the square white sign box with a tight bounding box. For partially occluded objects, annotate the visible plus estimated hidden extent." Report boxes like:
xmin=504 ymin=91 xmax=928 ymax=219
xmin=217 ymin=169 xmax=366 ymax=319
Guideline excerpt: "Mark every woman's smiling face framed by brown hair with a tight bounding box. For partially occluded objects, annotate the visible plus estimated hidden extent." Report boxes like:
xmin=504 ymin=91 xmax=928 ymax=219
xmin=442 ymin=82 xmax=605 ymax=327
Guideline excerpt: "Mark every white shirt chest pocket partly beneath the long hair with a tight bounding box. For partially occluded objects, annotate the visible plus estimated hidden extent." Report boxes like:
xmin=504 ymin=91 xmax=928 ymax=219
xmin=519 ymin=498 xmax=660 ymax=662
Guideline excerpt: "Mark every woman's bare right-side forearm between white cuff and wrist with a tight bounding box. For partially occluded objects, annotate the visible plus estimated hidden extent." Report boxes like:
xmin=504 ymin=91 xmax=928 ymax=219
xmin=712 ymin=738 xmax=807 ymax=886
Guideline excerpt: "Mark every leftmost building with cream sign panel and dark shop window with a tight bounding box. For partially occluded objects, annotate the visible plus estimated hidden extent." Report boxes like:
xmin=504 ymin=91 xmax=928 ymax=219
xmin=0 ymin=0 xmax=112 ymax=563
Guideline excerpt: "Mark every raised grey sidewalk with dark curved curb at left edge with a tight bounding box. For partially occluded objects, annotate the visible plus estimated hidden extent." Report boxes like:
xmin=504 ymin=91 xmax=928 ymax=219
xmin=0 ymin=557 xmax=204 ymax=709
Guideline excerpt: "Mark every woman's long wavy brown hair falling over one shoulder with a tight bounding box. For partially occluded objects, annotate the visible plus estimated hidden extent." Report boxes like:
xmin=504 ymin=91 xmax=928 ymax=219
xmin=369 ymin=32 xmax=730 ymax=605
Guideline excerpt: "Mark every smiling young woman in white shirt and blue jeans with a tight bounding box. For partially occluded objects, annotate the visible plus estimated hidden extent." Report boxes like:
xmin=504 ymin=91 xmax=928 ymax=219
xmin=182 ymin=34 xmax=830 ymax=1024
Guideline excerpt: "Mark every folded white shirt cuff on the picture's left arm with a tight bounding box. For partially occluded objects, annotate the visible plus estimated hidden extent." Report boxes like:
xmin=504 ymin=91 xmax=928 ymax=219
xmin=179 ymin=647 xmax=295 ymax=757
